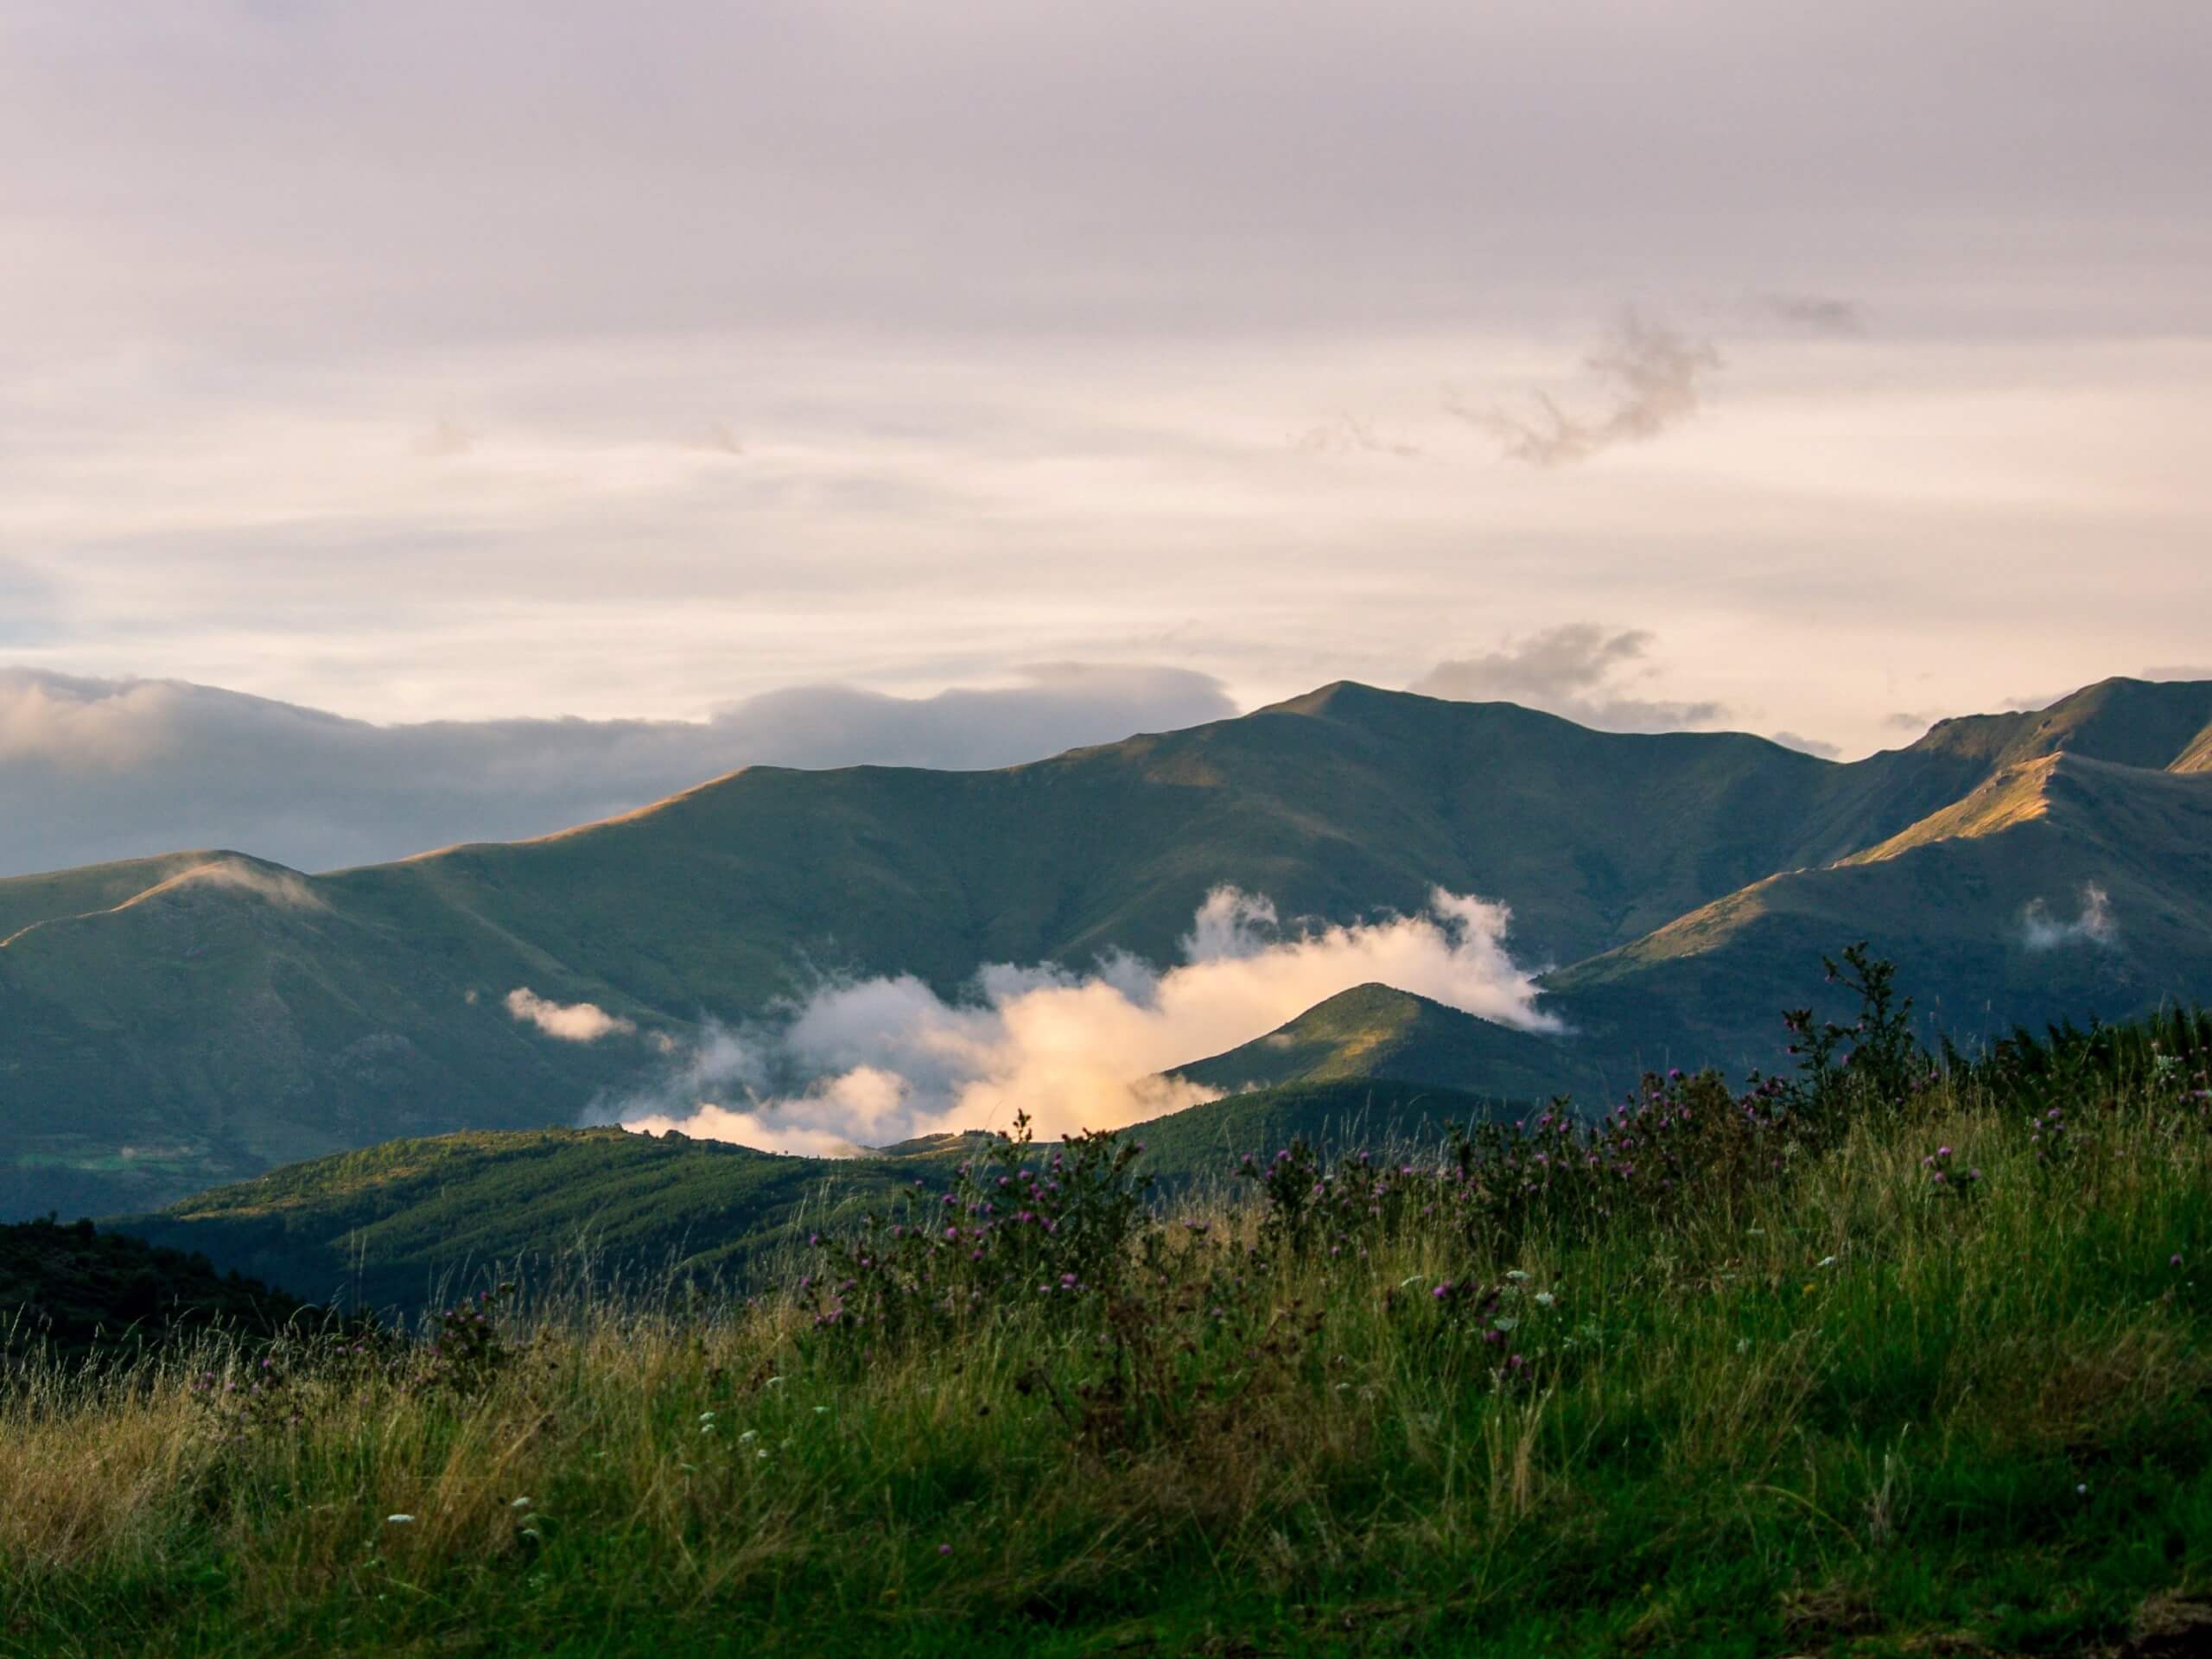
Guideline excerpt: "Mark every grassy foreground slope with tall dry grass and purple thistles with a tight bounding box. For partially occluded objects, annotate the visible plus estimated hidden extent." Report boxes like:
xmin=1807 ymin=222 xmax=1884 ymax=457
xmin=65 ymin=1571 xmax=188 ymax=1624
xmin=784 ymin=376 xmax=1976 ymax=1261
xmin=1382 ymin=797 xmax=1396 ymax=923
xmin=0 ymin=995 xmax=2212 ymax=1659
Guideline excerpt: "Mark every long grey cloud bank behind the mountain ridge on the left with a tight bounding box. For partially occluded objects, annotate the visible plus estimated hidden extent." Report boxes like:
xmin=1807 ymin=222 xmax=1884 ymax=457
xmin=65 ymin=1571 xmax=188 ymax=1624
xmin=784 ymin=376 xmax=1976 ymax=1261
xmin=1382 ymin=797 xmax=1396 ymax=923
xmin=0 ymin=664 xmax=1236 ymax=876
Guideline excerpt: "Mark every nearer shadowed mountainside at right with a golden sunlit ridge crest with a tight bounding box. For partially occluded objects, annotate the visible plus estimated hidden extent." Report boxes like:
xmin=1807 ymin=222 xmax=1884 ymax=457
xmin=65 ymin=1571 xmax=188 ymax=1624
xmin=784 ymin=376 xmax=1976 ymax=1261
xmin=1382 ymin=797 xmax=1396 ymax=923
xmin=1551 ymin=752 xmax=2212 ymax=1068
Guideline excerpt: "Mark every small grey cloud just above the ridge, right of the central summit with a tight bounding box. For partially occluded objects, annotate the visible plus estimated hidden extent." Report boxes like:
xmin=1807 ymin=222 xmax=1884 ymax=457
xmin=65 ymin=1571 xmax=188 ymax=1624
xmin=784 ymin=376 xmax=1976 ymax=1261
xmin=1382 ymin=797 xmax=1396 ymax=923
xmin=1409 ymin=621 xmax=1727 ymax=732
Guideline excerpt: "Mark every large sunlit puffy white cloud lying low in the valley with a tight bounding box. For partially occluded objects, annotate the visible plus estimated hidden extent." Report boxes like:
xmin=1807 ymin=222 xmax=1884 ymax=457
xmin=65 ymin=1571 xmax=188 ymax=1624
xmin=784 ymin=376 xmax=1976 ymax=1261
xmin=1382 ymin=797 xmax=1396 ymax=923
xmin=614 ymin=887 xmax=1561 ymax=1150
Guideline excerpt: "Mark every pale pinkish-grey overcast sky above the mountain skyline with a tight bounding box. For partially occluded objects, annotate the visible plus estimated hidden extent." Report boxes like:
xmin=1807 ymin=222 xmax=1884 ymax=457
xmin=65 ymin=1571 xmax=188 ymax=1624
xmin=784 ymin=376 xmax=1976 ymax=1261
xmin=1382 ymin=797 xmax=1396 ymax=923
xmin=0 ymin=0 xmax=2212 ymax=868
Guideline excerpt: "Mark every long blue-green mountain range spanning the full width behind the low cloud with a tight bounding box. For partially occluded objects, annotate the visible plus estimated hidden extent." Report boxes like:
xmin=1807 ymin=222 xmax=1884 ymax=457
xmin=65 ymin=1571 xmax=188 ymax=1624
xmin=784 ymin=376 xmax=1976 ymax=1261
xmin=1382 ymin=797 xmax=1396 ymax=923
xmin=0 ymin=681 xmax=2212 ymax=1214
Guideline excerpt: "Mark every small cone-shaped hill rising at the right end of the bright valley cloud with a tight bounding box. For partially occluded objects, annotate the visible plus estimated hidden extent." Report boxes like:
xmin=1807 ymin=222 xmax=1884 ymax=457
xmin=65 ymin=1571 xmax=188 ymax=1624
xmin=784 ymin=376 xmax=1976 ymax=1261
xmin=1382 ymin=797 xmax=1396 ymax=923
xmin=1177 ymin=984 xmax=1595 ymax=1099
